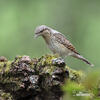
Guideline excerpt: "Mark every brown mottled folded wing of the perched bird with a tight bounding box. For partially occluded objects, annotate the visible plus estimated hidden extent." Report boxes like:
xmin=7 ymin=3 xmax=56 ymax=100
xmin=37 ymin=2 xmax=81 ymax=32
xmin=53 ymin=33 xmax=79 ymax=54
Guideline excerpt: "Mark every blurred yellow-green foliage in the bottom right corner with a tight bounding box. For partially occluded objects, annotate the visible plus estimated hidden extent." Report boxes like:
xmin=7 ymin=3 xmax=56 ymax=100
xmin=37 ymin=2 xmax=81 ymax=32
xmin=62 ymin=69 xmax=100 ymax=100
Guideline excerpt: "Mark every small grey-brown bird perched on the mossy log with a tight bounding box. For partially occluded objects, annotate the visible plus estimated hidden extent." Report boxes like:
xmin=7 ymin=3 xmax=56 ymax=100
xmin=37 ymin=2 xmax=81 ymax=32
xmin=34 ymin=25 xmax=94 ymax=66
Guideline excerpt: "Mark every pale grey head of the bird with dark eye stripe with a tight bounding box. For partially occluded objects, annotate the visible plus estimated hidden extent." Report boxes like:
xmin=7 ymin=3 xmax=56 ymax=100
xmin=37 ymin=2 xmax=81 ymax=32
xmin=34 ymin=25 xmax=50 ymax=38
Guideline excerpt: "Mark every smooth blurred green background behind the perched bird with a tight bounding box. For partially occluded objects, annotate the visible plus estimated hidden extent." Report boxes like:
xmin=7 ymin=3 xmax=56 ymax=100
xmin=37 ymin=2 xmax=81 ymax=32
xmin=0 ymin=0 xmax=100 ymax=70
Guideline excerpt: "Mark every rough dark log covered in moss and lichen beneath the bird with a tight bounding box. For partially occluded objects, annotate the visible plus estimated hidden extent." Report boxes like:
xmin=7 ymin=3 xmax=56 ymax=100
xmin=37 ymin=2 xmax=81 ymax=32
xmin=0 ymin=55 xmax=81 ymax=100
